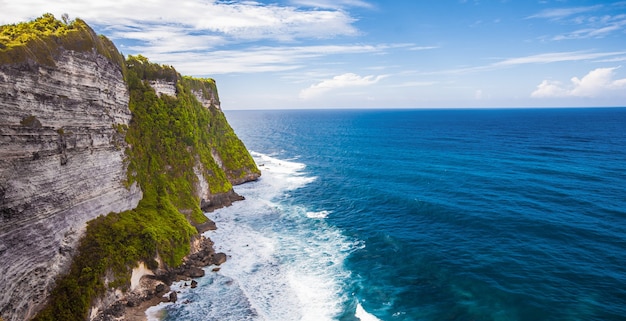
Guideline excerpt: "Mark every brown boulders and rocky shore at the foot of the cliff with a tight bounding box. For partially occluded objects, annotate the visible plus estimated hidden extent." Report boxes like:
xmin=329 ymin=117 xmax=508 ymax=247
xmin=90 ymin=235 xmax=226 ymax=321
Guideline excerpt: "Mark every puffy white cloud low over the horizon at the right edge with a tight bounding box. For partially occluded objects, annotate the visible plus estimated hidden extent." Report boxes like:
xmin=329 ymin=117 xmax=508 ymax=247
xmin=531 ymin=67 xmax=626 ymax=98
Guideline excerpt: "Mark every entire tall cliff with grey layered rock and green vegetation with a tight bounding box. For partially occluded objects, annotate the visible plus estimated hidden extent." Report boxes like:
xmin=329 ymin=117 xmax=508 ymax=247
xmin=0 ymin=15 xmax=260 ymax=320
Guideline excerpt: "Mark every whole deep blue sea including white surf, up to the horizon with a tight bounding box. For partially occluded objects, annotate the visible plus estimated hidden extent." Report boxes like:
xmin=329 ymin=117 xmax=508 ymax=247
xmin=148 ymin=108 xmax=626 ymax=321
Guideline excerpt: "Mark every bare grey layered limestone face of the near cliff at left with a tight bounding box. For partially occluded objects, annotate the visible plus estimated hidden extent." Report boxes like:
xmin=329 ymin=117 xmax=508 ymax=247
xmin=0 ymin=50 xmax=142 ymax=320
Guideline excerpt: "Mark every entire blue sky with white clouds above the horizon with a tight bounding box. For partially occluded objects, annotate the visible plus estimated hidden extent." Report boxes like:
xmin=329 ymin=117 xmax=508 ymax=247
xmin=0 ymin=0 xmax=626 ymax=110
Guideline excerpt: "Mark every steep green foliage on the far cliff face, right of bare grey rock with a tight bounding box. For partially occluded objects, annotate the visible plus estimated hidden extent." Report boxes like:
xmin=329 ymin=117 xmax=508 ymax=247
xmin=126 ymin=56 xmax=234 ymax=200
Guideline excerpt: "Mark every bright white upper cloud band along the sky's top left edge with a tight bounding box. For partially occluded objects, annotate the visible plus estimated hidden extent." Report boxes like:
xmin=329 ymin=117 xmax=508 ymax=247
xmin=0 ymin=0 xmax=357 ymax=41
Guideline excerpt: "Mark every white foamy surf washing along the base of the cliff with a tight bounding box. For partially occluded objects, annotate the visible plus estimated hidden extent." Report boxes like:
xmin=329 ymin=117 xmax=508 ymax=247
xmin=150 ymin=153 xmax=368 ymax=321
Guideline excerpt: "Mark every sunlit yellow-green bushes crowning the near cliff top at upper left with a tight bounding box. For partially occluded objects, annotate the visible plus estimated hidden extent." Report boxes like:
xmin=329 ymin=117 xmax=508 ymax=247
xmin=0 ymin=13 xmax=124 ymax=67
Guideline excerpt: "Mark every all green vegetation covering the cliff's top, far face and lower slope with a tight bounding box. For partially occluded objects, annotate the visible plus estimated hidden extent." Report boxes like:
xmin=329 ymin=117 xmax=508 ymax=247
xmin=0 ymin=14 xmax=259 ymax=320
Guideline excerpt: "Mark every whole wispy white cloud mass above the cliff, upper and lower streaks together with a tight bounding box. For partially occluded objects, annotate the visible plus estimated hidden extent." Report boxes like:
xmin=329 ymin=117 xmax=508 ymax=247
xmin=0 ymin=0 xmax=386 ymax=76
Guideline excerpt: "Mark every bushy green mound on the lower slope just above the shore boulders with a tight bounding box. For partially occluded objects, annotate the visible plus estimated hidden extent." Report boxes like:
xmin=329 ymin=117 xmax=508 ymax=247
xmin=34 ymin=201 xmax=196 ymax=321
